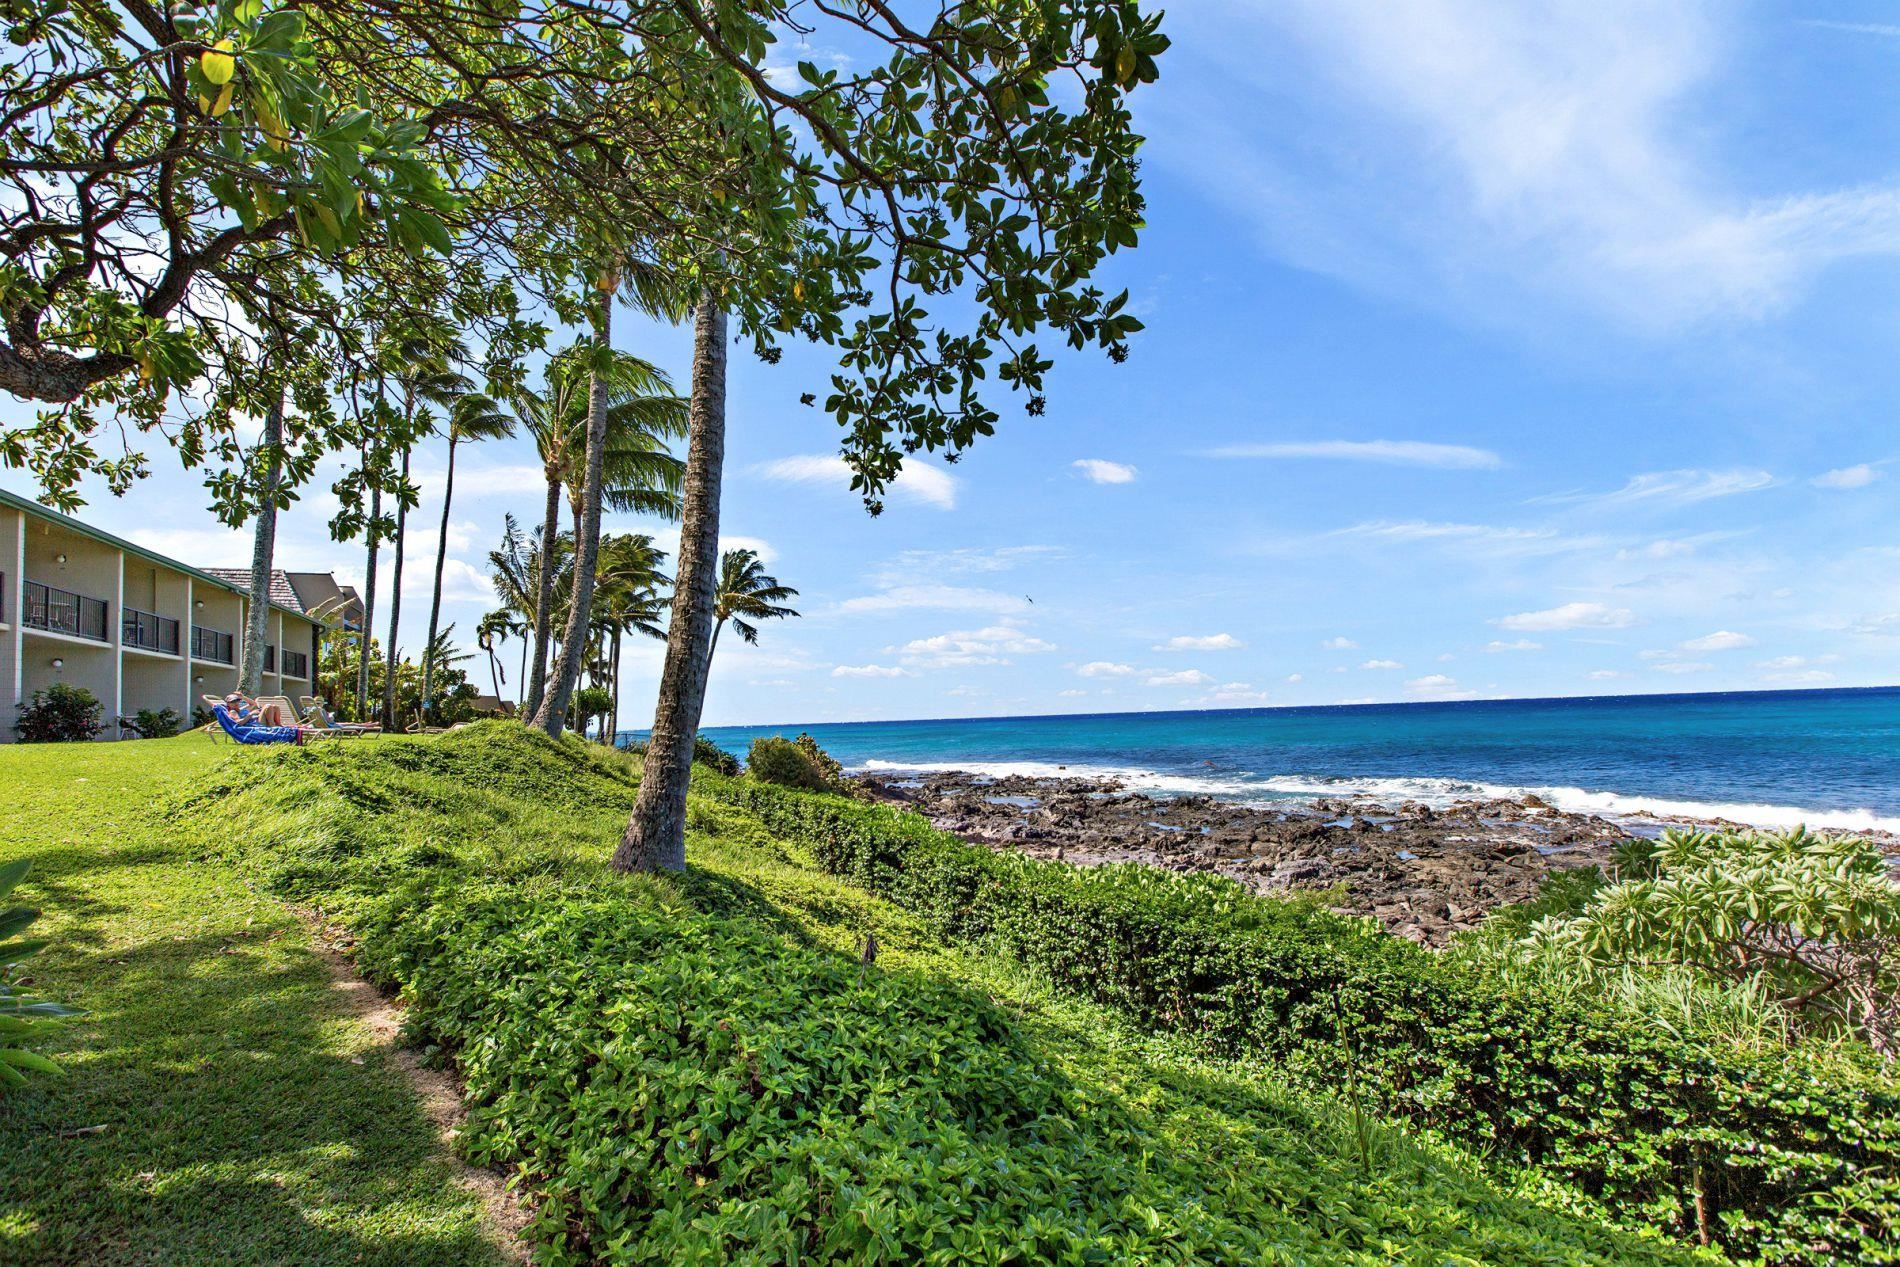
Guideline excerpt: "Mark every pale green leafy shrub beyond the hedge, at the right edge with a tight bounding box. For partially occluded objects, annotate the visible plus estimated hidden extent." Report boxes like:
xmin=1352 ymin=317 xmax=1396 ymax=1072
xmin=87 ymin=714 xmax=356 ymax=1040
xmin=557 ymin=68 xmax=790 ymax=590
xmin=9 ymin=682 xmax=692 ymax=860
xmin=1526 ymin=828 xmax=1900 ymax=1058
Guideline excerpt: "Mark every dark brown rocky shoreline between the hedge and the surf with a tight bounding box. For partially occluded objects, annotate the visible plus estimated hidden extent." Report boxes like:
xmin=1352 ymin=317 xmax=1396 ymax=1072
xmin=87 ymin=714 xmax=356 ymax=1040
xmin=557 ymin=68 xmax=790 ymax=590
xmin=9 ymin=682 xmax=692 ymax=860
xmin=857 ymin=771 xmax=1884 ymax=946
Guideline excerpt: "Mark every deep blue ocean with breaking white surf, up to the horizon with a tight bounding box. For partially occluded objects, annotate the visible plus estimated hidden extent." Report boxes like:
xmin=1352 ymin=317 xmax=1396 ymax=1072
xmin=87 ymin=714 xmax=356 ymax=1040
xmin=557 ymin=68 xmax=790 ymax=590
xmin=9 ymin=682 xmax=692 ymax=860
xmin=619 ymin=686 xmax=1900 ymax=834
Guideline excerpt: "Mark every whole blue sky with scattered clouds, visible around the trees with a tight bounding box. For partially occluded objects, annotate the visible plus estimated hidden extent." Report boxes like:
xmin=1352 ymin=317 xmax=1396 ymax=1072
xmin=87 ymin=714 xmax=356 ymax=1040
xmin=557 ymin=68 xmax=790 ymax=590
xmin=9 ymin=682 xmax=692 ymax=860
xmin=0 ymin=0 xmax=1900 ymax=726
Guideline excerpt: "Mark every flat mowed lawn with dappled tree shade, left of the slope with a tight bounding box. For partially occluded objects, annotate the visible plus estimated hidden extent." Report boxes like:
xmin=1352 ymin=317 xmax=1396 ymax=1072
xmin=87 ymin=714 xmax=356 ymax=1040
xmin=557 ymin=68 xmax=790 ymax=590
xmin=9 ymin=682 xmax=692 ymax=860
xmin=0 ymin=733 xmax=504 ymax=1265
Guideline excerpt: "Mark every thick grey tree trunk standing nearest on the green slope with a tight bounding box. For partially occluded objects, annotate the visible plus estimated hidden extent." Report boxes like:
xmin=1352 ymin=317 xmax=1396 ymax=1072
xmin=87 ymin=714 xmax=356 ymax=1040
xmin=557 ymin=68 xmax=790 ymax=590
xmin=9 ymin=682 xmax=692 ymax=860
xmin=614 ymin=293 xmax=726 ymax=872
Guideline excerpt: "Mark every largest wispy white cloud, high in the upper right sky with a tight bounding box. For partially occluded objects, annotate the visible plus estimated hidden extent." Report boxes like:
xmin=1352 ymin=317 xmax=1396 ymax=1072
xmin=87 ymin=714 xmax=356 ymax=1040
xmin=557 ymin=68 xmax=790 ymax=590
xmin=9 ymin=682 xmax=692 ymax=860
xmin=1155 ymin=0 xmax=1900 ymax=334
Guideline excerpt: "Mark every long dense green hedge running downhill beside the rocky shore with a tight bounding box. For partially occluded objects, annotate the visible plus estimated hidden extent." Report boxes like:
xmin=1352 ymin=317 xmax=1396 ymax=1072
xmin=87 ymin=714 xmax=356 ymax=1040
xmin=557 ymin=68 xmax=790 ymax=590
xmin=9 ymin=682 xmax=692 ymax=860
xmin=697 ymin=779 xmax=1900 ymax=1263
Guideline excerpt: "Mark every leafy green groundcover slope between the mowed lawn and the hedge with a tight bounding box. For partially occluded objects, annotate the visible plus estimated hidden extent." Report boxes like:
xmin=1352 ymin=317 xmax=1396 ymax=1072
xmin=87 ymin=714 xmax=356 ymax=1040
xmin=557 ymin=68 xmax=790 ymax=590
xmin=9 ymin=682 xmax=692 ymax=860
xmin=179 ymin=724 xmax=1689 ymax=1263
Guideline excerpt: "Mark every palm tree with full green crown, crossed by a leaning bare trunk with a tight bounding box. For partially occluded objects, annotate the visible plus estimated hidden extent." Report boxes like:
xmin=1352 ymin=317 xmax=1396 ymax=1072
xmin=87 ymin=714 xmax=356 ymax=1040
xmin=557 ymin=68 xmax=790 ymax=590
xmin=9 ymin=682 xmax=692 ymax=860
xmin=509 ymin=344 xmax=686 ymax=718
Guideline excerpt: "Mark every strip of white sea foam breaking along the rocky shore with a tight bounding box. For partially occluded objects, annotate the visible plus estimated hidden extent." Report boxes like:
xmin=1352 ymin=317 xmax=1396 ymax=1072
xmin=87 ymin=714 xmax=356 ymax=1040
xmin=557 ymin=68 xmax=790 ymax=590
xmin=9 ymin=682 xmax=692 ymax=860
xmin=859 ymin=760 xmax=1900 ymax=834
